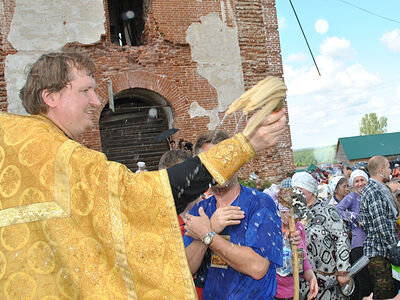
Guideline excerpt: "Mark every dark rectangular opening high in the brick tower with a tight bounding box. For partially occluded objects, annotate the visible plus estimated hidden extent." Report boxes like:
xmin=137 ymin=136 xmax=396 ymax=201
xmin=107 ymin=0 xmax=144 ymax=46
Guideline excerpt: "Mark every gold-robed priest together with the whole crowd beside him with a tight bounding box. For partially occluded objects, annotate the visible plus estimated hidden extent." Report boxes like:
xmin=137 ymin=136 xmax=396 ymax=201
xmin=0 ymin=52 xmax=400 ymax=300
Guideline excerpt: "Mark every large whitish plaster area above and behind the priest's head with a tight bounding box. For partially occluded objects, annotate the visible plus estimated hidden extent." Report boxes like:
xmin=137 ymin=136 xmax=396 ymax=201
xmin=5 ymin=0 xmax=105 ymax=113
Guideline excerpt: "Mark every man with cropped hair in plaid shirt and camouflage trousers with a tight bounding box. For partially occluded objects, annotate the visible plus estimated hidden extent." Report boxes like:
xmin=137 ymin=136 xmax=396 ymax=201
xmin=360 ymin=156 xmax=399 ymax=299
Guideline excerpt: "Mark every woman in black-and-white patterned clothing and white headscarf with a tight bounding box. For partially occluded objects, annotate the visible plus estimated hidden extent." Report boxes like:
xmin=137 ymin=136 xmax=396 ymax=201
xmin=292 ymin=172 xmax=350 ymax=300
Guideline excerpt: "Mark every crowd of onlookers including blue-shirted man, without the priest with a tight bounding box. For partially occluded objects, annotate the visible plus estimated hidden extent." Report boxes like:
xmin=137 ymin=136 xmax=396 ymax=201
xmin=155 ymin=142 xmax=400 ymax=300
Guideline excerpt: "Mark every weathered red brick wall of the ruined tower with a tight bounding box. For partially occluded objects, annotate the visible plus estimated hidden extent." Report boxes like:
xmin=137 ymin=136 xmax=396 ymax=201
xmin=0 ymin=0 xmax=294 ymax=181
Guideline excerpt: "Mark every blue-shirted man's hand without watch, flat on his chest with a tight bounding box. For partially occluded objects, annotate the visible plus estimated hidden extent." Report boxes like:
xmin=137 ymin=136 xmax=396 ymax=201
xmin=210 ymin=206 xmax=244 ymax=233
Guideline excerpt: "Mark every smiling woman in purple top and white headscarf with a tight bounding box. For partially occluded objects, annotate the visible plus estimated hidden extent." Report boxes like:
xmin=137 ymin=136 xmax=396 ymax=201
xmin=336 ymin=170 xmax=372 ymax=300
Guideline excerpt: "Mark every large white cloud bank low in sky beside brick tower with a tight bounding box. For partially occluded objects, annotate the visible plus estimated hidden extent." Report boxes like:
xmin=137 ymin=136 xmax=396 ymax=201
xmin=283 ymin=37 xmax=400 ymax=149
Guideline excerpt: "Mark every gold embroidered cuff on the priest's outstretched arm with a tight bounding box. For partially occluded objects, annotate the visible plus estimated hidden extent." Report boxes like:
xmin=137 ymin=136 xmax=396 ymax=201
xmin=199 ymin=133 xmax=255 ymax=184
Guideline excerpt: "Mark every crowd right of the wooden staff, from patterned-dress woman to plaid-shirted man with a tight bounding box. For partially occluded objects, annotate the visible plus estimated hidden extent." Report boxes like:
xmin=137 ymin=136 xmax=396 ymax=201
xmin=266 ymin=156 xmax=400 ymax=299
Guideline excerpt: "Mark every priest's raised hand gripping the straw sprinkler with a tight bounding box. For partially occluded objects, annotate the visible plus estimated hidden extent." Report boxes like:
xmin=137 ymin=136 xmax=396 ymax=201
xmin=242 ymin=109 xmax=286 ymax=152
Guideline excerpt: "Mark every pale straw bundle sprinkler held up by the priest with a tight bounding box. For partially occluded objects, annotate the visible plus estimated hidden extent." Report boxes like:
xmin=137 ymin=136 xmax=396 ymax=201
xmin=225 ymin=76 xmax=287 ymax=136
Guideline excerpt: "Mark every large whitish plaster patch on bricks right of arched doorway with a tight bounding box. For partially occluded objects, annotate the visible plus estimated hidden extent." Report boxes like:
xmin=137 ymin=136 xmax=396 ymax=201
xmin=186 ymin=13 xmax=244 ymax=112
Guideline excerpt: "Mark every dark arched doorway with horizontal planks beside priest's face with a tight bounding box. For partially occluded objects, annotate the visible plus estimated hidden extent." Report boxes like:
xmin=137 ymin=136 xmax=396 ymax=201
xmin=99 ymin=88 xmax=172 ymax=171
